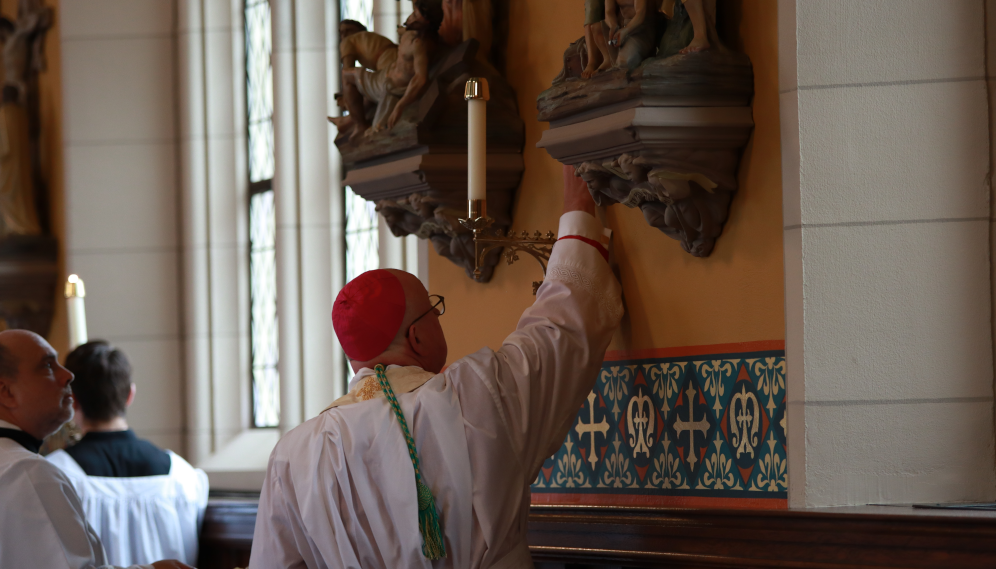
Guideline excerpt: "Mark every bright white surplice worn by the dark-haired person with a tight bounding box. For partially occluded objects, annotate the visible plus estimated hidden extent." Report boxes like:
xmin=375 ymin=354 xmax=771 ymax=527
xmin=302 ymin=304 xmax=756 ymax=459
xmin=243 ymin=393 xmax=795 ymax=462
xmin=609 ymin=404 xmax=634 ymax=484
xmin=47 ymin=450 xmax=208 ymax=566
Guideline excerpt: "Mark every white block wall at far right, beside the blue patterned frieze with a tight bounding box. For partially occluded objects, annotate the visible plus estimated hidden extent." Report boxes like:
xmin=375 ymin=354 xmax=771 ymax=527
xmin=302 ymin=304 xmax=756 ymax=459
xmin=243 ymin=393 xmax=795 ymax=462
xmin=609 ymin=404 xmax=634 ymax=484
xmin=778 ymin=0 xmax=996 ymax=506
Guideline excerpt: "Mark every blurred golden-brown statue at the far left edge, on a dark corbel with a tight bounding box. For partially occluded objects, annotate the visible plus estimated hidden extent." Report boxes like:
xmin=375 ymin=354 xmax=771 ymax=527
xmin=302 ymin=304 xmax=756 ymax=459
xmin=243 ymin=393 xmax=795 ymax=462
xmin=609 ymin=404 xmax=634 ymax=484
xmin=0 ymin=0 xmax=52 ymax=238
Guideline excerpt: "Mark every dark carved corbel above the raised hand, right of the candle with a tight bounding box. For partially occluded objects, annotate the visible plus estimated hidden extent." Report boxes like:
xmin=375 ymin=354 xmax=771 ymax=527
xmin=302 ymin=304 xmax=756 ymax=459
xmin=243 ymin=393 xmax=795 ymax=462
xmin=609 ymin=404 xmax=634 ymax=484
xmin=537 ymin=53 xmax=754 ymax=257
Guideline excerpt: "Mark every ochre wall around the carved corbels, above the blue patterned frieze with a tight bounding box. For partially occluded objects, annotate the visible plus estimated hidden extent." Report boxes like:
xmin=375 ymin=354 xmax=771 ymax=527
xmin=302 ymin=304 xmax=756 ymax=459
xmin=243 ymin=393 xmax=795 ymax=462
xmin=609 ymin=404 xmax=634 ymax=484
xmin=429 ymin=0 xmax=785 ymax=362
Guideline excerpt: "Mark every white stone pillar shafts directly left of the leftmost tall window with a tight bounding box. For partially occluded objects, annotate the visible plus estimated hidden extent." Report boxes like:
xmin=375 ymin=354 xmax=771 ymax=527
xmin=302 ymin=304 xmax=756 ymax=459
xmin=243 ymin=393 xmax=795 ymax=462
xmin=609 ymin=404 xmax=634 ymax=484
xmin=177 ymin=0 xmax=252 ymax=461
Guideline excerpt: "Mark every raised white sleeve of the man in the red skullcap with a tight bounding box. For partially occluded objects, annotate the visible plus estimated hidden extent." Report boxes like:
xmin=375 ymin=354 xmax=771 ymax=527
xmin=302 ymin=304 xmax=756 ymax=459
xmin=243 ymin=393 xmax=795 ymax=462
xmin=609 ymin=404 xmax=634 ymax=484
xmin=476 ymin=212 xmax=623 ymax=483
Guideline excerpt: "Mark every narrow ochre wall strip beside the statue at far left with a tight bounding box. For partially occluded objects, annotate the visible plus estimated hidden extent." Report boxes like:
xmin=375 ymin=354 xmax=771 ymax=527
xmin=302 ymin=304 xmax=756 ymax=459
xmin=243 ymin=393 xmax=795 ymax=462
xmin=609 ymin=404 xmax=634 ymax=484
xmin=0 ymin=0 xmax=69 ymax=356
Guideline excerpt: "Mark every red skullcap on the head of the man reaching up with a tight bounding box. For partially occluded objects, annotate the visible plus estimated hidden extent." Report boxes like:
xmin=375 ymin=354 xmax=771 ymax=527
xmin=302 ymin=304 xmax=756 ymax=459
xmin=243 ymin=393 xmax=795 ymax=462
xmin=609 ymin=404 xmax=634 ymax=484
xmin=332 ymin=269 xmax=405 ymax=362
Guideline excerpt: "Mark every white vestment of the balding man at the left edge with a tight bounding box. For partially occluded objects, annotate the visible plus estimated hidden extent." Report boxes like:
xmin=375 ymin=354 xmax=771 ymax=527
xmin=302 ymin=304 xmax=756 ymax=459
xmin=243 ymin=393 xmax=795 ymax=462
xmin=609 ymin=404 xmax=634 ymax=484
xmin=0 ymin=423 xmax=151 ymax=569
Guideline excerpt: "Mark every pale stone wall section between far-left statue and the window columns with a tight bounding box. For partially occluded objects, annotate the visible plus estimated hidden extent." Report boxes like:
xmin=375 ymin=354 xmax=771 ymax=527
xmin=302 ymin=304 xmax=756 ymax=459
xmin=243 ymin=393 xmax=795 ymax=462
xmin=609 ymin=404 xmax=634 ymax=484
xmin=57 ymin=0 xmax=185 ymax=454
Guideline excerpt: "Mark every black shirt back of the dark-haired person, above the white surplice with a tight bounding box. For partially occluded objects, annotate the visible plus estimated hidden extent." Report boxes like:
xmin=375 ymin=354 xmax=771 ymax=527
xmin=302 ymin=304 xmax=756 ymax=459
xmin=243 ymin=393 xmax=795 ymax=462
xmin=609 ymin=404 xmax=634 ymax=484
xmin=66 ymin=430 xmax=170 ymax=478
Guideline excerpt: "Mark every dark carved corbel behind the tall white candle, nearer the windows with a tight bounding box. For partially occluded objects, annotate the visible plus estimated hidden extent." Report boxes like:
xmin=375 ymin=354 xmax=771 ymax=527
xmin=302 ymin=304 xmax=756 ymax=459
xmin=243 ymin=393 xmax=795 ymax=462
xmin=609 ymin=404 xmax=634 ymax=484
xmin=336 ymin=39 xmax=525 ymax=282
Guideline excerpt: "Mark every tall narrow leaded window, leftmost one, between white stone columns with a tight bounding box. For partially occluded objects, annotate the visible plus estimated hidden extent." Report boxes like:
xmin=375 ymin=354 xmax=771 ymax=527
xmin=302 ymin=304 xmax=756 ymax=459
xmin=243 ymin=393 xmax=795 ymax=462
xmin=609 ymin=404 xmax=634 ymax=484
xmin=245 ymin=0 xmax=280 ymax=427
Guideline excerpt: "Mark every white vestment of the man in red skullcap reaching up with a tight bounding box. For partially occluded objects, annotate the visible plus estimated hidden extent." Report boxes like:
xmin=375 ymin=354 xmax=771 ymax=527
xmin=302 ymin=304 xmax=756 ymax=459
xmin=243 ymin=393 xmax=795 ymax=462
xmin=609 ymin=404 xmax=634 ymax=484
xmin=249 ymin=212 xmax=622 ymax=569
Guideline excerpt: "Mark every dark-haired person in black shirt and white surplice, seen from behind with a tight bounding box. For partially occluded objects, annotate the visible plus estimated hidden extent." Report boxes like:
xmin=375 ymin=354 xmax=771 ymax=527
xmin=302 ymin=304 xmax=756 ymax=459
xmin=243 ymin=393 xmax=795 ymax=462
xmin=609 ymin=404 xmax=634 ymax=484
xmin=48 ymin=340 xmax=208 ymax=565
